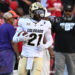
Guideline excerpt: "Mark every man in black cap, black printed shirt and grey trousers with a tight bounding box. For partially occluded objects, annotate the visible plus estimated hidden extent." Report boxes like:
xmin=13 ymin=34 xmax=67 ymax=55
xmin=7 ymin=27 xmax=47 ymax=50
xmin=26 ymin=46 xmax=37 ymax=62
xmin=52 ymin=4 xmax=75 ymax=75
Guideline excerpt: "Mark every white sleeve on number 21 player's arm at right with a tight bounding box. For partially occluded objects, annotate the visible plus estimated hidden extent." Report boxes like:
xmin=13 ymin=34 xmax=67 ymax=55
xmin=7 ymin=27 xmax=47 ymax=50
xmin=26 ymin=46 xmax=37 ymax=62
xmin=45 ymin=29 xmax=53 ymax=48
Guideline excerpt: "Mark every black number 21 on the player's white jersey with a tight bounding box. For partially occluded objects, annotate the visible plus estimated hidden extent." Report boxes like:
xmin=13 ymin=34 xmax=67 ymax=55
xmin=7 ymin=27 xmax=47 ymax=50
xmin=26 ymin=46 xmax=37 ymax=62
xmin=28 ymin=33 xmax=42 ymax=46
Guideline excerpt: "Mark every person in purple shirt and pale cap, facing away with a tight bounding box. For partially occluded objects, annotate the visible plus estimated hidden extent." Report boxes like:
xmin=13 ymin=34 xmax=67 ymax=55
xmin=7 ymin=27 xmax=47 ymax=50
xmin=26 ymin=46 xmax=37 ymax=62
xmin=0 ymin=12 xmax=19 ymax=75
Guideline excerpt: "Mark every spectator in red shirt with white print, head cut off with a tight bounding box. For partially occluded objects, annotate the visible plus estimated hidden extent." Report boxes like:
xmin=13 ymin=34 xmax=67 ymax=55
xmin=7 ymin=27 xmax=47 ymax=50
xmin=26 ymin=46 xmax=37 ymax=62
xmin=47 ymin=0 xmax=62 ymax=17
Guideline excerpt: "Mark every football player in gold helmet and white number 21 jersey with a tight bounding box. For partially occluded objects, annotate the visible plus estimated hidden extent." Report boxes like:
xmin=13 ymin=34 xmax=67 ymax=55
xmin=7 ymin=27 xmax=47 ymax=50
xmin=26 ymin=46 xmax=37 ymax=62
xmin=13 ymin=2 xmax=53 ymax=75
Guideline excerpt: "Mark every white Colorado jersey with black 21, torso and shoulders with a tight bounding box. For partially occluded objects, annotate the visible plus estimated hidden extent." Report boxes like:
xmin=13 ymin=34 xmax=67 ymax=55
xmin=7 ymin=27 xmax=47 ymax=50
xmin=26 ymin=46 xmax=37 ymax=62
xmin=17 ymin=18 xmax=52 ymax=57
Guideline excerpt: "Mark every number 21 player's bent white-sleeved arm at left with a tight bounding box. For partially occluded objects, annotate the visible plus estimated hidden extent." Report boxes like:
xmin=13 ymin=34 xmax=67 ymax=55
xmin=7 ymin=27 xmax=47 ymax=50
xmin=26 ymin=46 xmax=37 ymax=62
xmin=13 ymin=19 xmax=28 ymax=43
